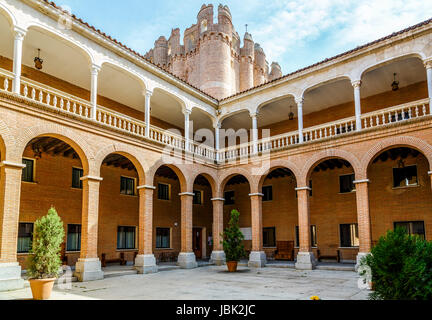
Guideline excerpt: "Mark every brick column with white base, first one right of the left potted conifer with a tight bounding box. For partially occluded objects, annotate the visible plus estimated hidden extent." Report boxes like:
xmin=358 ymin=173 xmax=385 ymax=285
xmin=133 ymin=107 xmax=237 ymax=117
xmin=75 ymin=176 xmax=103 ymax=281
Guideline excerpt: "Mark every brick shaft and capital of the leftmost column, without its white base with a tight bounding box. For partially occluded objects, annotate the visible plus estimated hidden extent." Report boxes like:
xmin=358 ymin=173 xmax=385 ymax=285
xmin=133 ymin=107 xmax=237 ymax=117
xmin=0 ymin=162 xmax=25 ymax=263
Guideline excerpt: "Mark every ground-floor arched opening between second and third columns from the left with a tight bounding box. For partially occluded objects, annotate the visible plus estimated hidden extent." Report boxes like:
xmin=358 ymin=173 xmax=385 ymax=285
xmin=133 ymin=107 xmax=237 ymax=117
xmin=98 ymin=153 xmax=140 ymax=267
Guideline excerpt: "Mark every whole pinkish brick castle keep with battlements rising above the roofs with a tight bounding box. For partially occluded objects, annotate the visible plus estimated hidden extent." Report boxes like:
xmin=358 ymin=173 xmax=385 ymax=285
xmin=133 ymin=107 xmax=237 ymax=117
xmin=145 ymin=4 xmax=282 ymax=99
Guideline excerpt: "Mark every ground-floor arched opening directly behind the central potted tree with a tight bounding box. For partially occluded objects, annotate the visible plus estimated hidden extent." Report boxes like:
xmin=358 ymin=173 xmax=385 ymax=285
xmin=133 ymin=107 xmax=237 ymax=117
xmin=221 ymin=174 xmax=252 ymax=259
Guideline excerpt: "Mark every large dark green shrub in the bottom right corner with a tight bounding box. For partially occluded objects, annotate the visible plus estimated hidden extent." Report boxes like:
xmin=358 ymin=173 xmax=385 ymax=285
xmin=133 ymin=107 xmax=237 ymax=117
xmin=361 ymin=228 xmax=432 ymax=300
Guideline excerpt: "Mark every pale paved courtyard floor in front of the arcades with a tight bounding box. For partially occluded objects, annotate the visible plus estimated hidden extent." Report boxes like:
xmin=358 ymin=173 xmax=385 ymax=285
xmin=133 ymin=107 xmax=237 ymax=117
xmin=0 ymin=266 xmax=369 ymax=300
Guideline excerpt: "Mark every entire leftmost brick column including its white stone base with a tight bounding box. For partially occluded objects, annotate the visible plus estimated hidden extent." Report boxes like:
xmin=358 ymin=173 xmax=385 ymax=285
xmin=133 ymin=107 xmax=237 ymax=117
xmin=0 ymin=161 xmax=25 ymax=291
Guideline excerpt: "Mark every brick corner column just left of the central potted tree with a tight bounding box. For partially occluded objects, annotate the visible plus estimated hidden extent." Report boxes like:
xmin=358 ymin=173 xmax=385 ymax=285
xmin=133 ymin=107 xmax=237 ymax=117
xmin=210 ymin=198 xmax=226 ymax=266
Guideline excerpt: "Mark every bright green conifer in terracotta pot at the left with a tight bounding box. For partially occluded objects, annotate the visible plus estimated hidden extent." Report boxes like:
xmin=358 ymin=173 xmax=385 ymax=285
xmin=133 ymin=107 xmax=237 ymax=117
xmin=27 ymin=208 xmax=65 ymax=300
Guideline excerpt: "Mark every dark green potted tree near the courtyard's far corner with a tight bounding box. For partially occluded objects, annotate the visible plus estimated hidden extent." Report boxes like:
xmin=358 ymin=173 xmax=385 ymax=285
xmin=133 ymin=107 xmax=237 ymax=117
xmin=221 ymin=210 xmax=246 ymax=272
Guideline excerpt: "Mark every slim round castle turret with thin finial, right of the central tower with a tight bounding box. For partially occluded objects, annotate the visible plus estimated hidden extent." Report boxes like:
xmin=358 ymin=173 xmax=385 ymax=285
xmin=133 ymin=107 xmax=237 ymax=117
xmin=240 ymin=32 xmax=255 ymax=91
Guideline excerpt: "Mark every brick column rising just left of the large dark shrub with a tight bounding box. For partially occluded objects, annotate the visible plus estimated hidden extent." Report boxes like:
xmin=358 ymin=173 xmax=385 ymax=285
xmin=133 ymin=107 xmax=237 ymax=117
xmin=354 ymin=180 xmax=372 ymax=270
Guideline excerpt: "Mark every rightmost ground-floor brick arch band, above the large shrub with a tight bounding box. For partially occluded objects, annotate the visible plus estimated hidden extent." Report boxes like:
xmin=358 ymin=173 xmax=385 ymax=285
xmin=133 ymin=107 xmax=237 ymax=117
xmin=359 ymin=136 xmax=432 ymax=179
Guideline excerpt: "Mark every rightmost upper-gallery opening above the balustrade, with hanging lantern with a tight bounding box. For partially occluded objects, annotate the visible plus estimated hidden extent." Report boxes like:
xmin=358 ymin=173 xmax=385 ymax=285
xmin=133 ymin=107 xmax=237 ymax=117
xmin=361 ymin=56 xmax=428 ymax=113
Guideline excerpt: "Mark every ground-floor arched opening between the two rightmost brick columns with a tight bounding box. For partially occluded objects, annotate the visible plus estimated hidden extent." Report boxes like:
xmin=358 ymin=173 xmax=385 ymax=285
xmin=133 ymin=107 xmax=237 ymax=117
xmin=307 ymin=157 xmax=360 ymax=264
